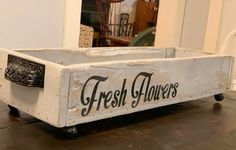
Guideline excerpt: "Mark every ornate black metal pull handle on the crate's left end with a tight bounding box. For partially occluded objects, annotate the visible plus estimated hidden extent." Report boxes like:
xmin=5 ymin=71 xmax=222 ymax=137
xmin=5 ymin=55 xmax=45 ymax=88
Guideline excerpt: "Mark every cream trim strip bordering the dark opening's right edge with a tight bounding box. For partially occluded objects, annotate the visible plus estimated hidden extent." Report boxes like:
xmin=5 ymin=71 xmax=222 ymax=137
xmin=155 ymin=0 xmax=186 ymax=47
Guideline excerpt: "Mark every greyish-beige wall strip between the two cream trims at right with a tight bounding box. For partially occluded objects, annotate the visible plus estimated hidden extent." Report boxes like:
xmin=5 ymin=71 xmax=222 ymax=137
xmin=180 ymin=0 xmax=210 ymax=49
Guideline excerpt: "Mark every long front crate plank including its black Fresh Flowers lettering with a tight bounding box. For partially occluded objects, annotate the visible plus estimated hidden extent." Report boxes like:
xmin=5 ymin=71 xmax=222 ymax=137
xmin=67 ymin=56 xmax=233 ymax=126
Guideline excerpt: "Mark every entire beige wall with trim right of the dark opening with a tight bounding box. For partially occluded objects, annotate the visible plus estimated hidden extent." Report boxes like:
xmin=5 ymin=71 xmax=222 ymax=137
xmin=155 ymin=0 xmax=236 ymax=52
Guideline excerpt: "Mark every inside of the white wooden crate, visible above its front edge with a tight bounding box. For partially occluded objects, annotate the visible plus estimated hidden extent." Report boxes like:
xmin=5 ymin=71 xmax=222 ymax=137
xmin=18 ymin=47 xmax=210 ymax=66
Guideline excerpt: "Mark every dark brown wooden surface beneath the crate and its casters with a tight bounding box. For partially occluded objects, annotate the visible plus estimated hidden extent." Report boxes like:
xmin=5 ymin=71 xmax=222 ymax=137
xmin=0 ymin=98 xmax=236 ymax=150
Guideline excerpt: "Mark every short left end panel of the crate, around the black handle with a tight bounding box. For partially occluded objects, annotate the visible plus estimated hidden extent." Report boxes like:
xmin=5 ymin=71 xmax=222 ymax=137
xmin=0 ymin=50 xmax=62 ymax=126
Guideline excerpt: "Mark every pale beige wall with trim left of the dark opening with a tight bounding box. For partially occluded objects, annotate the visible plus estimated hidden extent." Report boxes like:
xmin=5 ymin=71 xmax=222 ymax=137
xmin=0 ymin=0 xmax=81 ymax=48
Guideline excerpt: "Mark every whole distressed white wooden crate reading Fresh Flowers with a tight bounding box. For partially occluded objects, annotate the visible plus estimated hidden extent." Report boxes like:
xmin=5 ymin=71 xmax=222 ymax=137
xmin=0 ymin=47 xmax=233 ymax=127
